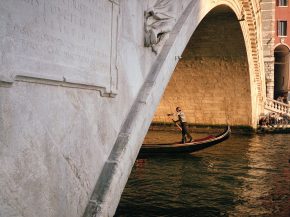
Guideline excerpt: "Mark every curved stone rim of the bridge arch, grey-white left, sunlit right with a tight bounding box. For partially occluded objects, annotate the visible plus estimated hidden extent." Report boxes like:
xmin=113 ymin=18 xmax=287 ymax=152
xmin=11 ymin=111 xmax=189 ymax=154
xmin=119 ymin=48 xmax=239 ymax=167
xmin=84 ymin=0 xmax=265 ymax=216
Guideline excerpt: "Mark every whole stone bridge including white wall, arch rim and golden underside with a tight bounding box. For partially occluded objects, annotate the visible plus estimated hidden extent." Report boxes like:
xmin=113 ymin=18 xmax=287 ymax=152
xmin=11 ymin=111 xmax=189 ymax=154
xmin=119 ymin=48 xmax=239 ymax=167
xmin=0 ymin=0 xmax=266 ymax=217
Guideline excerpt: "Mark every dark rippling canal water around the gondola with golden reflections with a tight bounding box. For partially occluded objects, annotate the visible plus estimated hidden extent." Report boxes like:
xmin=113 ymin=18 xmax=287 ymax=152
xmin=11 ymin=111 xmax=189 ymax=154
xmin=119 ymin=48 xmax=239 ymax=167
xmin=115 ymin=131 xmax=290 ymax=217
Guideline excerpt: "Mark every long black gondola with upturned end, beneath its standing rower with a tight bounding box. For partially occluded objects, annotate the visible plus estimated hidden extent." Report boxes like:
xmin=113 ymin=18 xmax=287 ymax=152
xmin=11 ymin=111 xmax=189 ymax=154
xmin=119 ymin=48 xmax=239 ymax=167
xmin=139 ymin=126 xmax=231 ymax=156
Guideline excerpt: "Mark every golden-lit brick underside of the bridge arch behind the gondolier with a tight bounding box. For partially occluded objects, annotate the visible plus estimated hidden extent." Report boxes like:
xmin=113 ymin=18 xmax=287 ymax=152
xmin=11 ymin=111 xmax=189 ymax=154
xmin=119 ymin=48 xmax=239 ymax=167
xmin=154 ymin=5 xmax=252 ymax=126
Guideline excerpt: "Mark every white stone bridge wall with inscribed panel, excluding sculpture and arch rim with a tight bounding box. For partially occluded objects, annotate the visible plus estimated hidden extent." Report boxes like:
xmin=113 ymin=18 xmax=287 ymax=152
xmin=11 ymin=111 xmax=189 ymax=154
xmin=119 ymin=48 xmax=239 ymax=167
xmin=0 ymin=0 xmax=193 ymax=217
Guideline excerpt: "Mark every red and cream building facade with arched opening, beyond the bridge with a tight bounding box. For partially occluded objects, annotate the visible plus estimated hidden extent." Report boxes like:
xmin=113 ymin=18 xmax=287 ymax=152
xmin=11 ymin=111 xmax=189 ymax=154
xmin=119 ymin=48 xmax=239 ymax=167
xmin=261 ymin=0 xmax=290 ymax=100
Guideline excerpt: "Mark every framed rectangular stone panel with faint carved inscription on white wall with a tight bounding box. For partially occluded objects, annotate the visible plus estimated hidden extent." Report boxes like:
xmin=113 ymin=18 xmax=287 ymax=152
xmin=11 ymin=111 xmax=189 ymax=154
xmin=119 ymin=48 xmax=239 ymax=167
xmin=0 ymin=0 xmax=120 ymax=96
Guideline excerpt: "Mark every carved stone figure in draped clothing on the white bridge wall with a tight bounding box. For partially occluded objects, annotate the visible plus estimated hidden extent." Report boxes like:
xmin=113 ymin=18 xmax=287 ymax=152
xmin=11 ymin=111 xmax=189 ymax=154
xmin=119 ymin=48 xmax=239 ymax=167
xmin=145 ymin=0 xmax=178 ymax=54
